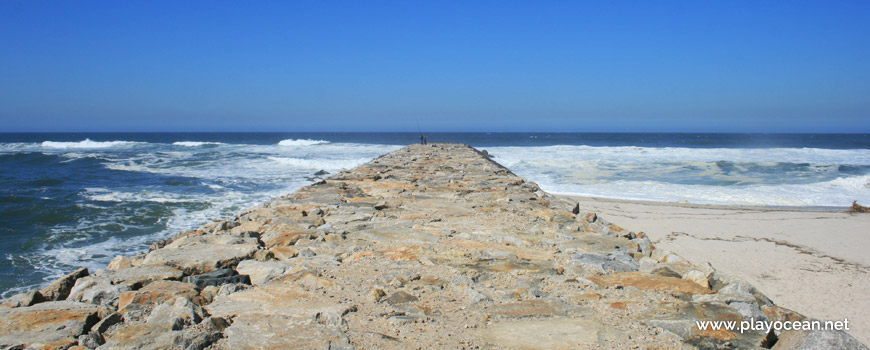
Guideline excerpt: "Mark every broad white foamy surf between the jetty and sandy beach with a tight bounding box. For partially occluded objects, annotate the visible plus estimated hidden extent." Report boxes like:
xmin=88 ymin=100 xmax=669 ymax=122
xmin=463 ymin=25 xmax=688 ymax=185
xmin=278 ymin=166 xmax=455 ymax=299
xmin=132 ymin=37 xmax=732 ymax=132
xmin=487 ymin=146 xmax=870 ymax=207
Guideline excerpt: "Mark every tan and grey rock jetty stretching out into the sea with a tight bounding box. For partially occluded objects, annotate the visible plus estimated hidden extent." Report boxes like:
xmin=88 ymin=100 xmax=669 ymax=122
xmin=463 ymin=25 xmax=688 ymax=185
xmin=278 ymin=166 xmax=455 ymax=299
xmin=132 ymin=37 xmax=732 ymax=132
xmin=0 ymin=144 xmax=866 ymax=349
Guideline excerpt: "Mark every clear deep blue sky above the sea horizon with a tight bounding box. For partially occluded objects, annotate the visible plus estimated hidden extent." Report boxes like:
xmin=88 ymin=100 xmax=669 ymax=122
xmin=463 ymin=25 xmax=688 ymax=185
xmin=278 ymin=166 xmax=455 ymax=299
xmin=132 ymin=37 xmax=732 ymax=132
xmin=0 ymin=0 xmax=870 ymax=133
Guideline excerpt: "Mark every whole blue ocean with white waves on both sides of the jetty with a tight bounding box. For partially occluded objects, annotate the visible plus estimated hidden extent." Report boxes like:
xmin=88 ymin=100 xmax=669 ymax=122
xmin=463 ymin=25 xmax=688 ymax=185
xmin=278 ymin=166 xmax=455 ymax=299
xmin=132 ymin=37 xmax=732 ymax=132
xmin=0 ymin=133 xmax=870 ymax=297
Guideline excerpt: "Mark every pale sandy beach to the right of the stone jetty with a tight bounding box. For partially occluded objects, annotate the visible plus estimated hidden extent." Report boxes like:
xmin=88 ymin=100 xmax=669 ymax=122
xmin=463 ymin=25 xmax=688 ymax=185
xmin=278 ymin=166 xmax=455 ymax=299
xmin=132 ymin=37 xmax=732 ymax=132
xmin=572 ymin=197 xmax=870 ymax=344
